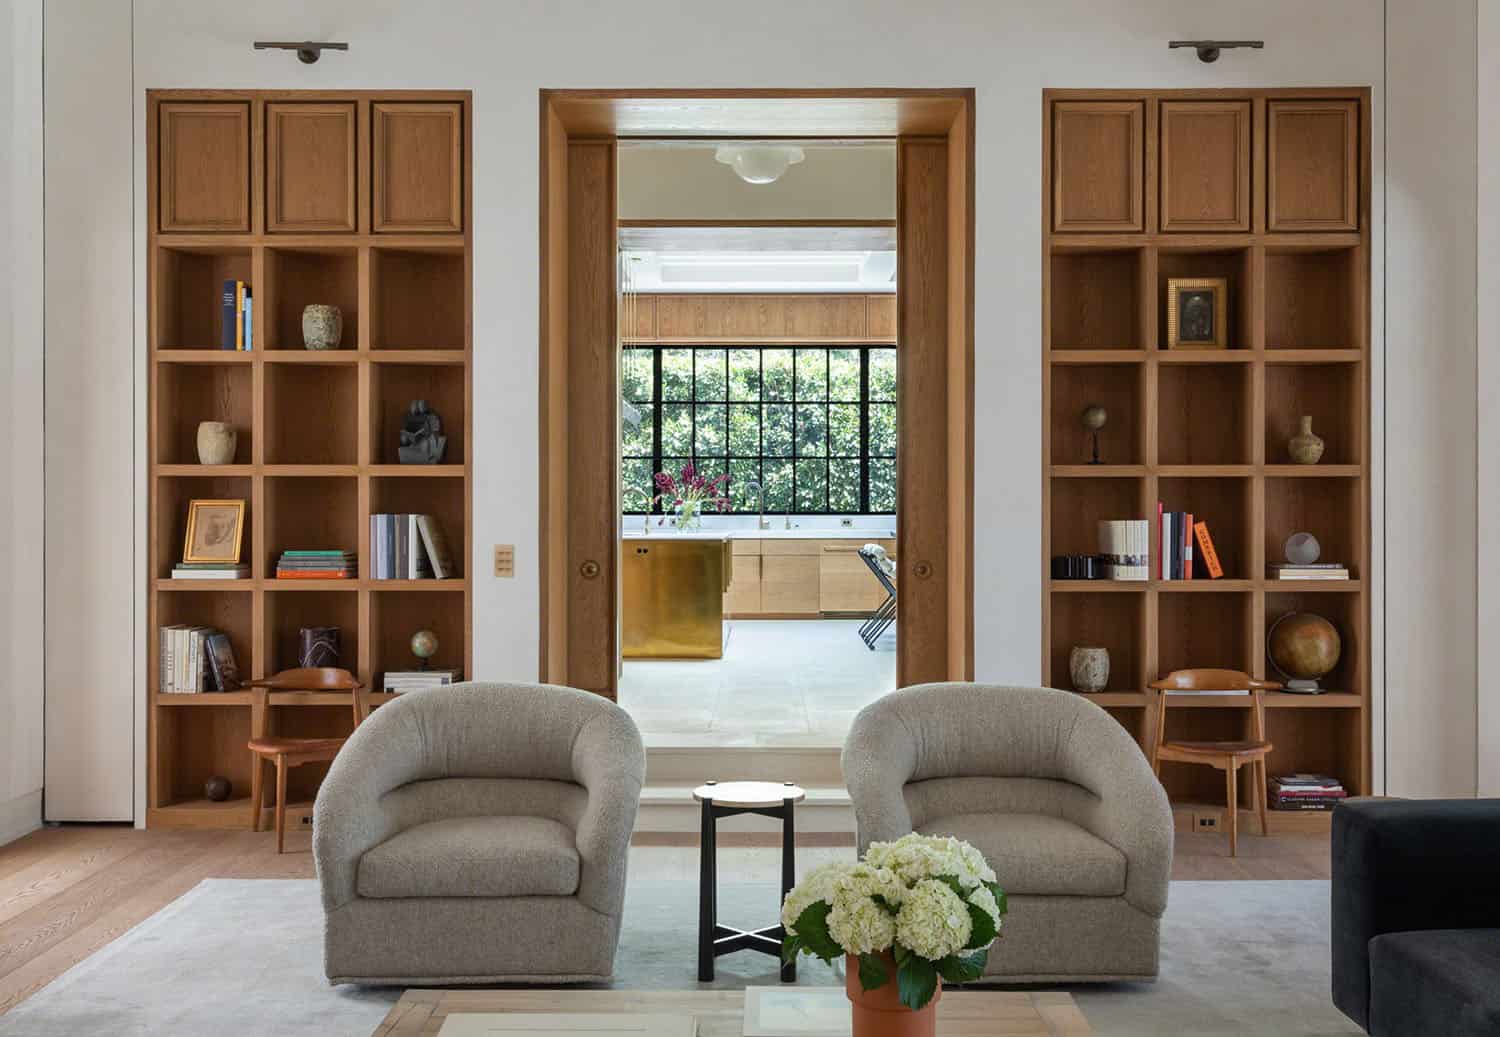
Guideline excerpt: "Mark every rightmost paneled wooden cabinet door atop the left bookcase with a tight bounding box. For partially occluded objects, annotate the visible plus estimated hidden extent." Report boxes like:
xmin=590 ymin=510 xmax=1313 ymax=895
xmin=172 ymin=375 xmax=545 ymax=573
xmin=372 ymin=102 xmax=464 ymax=234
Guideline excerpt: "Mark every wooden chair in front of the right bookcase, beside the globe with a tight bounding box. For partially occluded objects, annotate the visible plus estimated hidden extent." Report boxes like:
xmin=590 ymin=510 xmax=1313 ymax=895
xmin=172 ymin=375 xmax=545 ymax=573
xmin=1151 ymin=669 xmax=1281 ymax=857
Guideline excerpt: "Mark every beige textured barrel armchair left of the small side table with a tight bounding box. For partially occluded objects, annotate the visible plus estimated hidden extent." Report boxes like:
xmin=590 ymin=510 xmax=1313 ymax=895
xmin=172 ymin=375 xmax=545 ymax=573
xmin=312 ymin=683 xmax=645 ymax=984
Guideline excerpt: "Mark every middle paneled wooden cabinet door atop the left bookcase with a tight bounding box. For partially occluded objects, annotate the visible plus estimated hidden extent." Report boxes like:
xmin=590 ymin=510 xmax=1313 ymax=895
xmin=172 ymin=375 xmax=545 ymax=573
xmin=266 ymin=102 xmax=356 ymax=234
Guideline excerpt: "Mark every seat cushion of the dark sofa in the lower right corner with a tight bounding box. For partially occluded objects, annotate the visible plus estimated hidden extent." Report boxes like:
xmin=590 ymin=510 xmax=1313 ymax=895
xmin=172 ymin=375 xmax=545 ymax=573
xmin=1370 ymin=929 xmax=1500 ymax=1037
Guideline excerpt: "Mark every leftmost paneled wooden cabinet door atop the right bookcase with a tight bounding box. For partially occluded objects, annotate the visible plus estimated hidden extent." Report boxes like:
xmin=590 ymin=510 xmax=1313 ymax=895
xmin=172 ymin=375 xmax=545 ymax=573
xmin=1052 ymin=101 xmax=1146 ymax=233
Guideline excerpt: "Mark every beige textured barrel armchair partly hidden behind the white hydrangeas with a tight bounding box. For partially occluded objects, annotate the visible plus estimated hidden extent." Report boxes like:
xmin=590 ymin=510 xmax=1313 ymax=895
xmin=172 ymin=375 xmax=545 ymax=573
xmin=843 ymin=683 xmax=1172 ymax=981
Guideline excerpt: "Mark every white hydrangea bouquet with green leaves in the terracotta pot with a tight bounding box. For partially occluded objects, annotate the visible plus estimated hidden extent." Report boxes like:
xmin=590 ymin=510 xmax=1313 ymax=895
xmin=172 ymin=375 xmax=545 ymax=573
xmin=782 ymin=834 xmax=1005 ymax=1011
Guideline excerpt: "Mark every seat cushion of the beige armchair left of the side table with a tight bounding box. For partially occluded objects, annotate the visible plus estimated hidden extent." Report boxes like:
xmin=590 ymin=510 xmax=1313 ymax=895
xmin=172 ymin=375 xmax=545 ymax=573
xmin=357 ymin=815 xmax=579 ymax=897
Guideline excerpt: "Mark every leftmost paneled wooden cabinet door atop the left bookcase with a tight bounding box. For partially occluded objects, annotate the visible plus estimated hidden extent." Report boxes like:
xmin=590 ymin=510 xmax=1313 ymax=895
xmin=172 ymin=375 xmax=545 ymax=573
xmin=158 ymin=101 xmax=251 ymax=233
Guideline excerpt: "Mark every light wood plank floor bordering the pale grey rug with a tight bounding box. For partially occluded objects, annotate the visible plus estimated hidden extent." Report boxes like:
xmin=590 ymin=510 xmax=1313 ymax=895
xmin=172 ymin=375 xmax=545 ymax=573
xmin=0 ymin=825 xmax=1329 ymax=1013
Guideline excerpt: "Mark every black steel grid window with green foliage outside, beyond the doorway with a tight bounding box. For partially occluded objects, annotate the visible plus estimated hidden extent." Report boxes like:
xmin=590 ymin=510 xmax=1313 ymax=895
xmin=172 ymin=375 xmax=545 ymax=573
xmin=621 ymin=345 xmax=896 ymax=515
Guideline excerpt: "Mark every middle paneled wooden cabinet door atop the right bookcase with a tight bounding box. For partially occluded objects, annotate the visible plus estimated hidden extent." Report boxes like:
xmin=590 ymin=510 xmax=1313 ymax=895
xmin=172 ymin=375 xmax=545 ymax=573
xmin=1161 ymin=101 xmax=1250 ymax=234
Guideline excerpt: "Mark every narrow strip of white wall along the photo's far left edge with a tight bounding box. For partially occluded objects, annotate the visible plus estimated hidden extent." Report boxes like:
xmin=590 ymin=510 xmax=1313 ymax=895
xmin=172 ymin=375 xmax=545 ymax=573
xmin=0 ymin=0 xmax=44 ymax=843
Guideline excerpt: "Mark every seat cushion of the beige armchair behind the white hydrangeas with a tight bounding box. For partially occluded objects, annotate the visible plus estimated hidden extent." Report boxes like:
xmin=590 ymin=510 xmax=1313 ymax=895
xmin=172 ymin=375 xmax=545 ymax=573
xmin=918 ymin=813 xmax=1125 ymax=896
